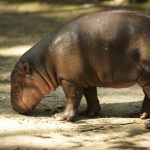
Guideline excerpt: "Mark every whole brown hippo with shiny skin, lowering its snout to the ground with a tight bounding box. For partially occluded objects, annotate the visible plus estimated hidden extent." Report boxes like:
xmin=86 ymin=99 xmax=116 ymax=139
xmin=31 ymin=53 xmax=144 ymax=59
xmin=11 ymin=11 xmax=150 ymax=121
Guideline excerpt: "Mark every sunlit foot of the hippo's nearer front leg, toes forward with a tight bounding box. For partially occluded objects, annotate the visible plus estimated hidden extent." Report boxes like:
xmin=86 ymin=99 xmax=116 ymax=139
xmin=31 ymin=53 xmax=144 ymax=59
xmin=54 ymin=111 xmax=76 ymax=122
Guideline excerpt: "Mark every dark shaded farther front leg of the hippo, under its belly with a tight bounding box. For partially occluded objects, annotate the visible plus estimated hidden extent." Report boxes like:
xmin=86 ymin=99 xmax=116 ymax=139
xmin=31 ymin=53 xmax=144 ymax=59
xmin=79 ymin=87 xmax=101 ymax=117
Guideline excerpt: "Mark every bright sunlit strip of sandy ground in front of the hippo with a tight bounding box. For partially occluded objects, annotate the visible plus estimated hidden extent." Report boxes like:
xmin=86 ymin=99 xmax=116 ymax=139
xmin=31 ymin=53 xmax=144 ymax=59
xmin=0 ymin=117 xmax=150 ymax=150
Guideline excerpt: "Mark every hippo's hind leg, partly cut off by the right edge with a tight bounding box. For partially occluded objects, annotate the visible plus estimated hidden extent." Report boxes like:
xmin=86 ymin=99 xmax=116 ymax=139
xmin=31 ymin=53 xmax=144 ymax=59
xmin=138 ymin=71 xmax=150 ymax=119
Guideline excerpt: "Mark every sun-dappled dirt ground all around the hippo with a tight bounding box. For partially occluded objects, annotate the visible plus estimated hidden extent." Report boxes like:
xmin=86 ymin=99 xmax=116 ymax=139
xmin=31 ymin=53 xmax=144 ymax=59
xmin=0 ymin=0 xmax=150 ymax=150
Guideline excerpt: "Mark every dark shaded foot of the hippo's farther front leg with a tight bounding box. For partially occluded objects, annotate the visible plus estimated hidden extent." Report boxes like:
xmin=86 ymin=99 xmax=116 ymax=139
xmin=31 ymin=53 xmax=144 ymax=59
xmin=79 ymin=106 xmax=101 ymax=117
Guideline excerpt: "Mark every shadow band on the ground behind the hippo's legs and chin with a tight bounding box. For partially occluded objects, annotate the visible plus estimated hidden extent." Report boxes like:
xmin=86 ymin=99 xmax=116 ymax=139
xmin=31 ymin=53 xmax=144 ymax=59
xmin=29 ymin=98 xmax=142 ymax=120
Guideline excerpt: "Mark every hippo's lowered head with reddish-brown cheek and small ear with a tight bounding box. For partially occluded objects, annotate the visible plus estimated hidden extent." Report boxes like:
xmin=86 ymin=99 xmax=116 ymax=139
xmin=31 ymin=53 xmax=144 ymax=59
xmin=11 ymin=61 xmax=50 ymax=114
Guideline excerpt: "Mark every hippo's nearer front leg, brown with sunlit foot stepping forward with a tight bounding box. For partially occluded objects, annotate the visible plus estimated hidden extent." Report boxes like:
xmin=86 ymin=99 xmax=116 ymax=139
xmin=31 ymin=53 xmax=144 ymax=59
xmin=54 ymin=80 xmax=83 ymax=121
